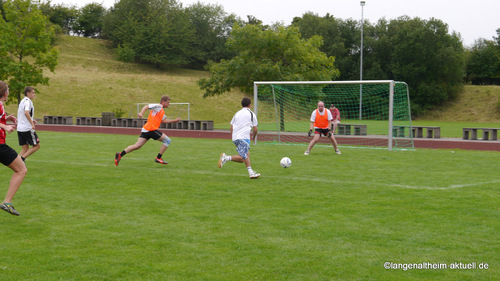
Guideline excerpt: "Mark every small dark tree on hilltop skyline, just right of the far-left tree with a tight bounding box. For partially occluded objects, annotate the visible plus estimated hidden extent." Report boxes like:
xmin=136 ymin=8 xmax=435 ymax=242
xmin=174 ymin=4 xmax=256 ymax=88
xmin=73 ymin=3 xmax=106 ymax=38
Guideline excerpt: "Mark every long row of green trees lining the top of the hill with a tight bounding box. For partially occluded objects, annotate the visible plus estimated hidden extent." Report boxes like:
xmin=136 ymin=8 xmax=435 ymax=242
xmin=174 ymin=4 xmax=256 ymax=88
xmin=0 ymin=0 xmax=500 ymax=113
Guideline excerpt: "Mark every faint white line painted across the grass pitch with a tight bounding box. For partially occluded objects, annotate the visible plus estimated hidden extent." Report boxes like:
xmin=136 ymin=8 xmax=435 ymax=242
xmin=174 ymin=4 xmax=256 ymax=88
xmin=32 ymin=160 xmax=500 ymax=190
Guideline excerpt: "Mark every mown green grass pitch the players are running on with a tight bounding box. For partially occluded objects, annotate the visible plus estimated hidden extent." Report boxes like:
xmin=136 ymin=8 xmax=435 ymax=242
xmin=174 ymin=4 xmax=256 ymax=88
xmin=0 ymin=132 xmax=500 ymax=280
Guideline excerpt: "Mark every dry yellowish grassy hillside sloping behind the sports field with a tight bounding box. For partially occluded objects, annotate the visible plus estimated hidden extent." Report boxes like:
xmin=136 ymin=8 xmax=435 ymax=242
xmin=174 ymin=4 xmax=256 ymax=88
xmin=7 ymin=36 xmax=500 ymax=126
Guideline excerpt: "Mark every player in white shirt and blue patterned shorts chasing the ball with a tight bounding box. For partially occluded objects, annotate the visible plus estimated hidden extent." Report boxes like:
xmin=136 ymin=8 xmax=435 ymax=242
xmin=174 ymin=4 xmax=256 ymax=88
xmin=219 ymin=97 xmax=260 ymax=179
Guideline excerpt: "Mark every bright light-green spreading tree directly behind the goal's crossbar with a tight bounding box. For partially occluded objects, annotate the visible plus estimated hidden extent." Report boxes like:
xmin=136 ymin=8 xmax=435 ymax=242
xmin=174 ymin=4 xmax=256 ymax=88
xmin=198 ymin=24 xmax=339 ymax=97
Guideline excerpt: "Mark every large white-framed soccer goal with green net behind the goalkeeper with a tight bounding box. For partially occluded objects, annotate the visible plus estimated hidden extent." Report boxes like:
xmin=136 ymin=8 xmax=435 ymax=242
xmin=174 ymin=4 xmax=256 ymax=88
xmin=254 ymin=80 xmax=414 ymax=150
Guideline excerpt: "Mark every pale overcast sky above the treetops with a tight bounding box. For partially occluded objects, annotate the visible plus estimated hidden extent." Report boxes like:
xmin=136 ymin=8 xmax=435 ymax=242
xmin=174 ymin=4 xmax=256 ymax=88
xmin=52 ymin=0 xmax=500 ymax=47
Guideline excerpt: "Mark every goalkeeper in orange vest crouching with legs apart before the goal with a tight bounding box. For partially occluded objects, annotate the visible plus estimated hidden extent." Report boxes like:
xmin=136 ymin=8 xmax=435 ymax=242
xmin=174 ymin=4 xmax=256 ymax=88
xmin=304 ymin=101 xmax=341 ymax=155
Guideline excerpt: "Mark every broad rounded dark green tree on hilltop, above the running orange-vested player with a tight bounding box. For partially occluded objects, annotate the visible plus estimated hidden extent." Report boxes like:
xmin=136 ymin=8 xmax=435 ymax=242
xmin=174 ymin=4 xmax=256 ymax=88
xmin=103 ymin=0 xmax=195 ymax=67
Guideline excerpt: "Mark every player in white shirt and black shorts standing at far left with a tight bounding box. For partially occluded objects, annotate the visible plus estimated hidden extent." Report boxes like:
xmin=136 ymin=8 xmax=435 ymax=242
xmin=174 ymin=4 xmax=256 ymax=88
xmin=17 ymin=87 xmax=40 ymax=161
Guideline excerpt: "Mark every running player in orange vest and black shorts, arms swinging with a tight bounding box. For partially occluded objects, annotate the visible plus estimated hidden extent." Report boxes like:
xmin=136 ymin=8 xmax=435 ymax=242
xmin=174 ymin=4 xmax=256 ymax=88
xmin=115 ymin=96 xmax=181 ymax=166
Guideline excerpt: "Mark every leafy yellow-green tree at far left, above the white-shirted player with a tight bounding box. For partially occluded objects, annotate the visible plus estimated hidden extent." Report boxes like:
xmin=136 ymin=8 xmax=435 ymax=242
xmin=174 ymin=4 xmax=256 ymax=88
xmin=0 ymin=0 xmax=59 ymax=102
